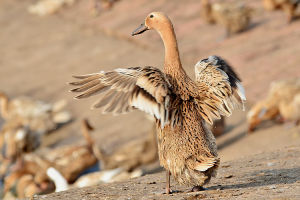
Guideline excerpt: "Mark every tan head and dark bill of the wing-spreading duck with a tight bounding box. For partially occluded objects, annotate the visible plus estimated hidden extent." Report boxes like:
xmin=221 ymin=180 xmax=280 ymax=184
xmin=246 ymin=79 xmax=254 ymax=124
xmin=132 ymin=12 xmax=172 ymax=36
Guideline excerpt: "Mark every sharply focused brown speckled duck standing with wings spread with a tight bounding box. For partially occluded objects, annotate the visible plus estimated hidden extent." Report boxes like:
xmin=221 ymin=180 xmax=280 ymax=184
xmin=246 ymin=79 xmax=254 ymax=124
xmin=70 ymin=12 xmax=245 ymax=193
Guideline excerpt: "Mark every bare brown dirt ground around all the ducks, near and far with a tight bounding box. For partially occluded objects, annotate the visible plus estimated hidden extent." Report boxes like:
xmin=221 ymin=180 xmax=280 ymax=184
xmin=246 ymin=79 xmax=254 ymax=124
xmin=0 ymin=0 xmax=300 ymax=199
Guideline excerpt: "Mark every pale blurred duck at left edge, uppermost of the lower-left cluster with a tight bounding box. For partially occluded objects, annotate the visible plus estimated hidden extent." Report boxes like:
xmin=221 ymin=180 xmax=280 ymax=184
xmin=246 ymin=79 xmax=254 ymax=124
xmin=0 ymin=92 xmax=72 ymax=135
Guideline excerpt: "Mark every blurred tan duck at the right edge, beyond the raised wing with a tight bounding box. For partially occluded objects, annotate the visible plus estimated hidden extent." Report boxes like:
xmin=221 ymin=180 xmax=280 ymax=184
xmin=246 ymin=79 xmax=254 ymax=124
xmin=247 ymin=78 xmax=300 ymax=132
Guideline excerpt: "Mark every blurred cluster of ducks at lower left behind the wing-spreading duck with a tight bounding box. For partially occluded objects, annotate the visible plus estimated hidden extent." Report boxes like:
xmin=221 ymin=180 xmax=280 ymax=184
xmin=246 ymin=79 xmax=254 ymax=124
xmin=0 ymin=93 xmax=158 ymax=199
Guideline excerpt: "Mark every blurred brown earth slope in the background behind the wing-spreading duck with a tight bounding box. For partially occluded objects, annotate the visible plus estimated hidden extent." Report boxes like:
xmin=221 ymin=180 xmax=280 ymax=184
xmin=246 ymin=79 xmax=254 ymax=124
xmin=0 ymin=0 xmax=300 ymax=161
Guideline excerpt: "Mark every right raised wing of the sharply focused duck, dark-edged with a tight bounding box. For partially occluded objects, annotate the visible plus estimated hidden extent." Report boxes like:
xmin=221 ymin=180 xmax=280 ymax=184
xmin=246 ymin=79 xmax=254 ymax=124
xmin=195 ymin=56 xmax=246 ymax=124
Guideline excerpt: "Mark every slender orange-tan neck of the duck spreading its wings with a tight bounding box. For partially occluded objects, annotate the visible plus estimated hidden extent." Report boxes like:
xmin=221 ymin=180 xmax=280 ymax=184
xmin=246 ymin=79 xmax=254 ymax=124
xmin=159 ymin=24 xmax=185 ymax=76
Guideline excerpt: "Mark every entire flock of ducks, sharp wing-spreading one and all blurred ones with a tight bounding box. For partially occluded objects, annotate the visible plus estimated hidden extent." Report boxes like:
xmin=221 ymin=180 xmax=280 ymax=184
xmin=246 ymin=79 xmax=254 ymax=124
xmin=0 ymin=0 xmax=300 ymax=199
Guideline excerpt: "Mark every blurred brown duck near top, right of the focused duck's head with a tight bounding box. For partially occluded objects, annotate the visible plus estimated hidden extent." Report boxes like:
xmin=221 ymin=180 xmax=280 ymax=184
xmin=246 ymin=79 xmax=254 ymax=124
xmin=201 ymin=0 xmax=253 ymax=37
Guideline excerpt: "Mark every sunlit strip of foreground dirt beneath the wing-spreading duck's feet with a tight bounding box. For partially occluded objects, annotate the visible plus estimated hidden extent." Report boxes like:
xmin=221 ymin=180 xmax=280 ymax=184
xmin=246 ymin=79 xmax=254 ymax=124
xmin=34 ymin=146 xmax=300 ymax=200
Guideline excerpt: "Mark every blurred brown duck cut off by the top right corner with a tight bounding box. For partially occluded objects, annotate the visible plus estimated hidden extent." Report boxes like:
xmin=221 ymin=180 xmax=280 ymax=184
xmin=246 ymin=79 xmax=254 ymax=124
xmin=263 ymin=0 xmax=300 ymax=23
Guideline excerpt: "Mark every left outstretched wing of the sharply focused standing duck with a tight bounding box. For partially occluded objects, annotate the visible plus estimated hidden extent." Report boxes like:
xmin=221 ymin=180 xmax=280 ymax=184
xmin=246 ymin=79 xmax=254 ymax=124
xmin=70 ymin=66 xmax=171 ymax=127
